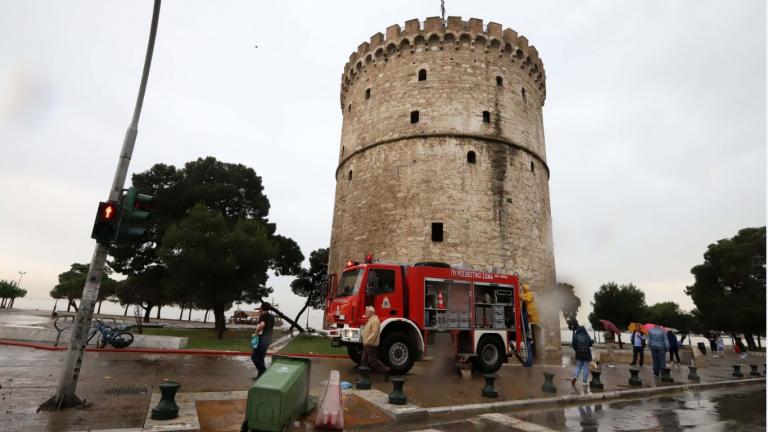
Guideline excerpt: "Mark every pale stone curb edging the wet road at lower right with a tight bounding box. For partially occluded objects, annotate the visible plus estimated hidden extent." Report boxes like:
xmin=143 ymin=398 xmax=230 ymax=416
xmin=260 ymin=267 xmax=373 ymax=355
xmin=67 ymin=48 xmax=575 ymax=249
xmin=352 ymin=377 xmax=765 ymax=422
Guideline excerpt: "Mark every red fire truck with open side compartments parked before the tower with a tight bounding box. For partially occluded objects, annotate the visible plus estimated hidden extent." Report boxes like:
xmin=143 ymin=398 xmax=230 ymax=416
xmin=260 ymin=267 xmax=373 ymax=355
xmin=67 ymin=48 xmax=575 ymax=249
xmin=324 ymin=255 xmax=527 ymax=374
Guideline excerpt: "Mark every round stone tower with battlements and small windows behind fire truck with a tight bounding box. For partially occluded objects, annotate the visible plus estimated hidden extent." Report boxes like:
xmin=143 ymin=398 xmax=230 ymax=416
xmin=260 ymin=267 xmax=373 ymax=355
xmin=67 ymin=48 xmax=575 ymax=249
xmin=329 ymin=17 xmax=560 ymax=362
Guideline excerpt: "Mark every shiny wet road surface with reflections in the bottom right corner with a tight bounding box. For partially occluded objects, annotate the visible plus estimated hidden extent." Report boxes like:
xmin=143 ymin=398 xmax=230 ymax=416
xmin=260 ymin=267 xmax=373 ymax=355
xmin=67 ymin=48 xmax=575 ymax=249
xmin=515 ymin=385 xmax=766 ymax=432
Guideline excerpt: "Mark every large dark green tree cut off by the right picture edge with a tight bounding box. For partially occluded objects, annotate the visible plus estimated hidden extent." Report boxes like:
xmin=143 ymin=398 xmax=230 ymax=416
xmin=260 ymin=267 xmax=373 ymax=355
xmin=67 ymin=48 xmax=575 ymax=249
xmin=685 ymin=227 xmax=765 ymax=349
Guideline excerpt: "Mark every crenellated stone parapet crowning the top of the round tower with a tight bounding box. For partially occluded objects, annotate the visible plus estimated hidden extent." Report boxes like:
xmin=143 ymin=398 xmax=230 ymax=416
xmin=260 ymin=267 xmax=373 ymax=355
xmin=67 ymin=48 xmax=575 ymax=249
xmin=341 ymin=17 xmax=546 ymax=107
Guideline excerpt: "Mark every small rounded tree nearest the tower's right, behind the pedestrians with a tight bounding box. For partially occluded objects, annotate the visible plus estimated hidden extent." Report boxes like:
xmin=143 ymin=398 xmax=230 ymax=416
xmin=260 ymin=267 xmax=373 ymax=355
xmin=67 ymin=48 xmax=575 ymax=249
xmin=589 ymin=282 xmax=647 ymax=329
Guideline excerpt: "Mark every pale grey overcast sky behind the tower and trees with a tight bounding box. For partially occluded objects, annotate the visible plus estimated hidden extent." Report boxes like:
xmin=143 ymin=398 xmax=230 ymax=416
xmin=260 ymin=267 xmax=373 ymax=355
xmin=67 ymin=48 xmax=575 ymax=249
xmin=0 ymin=0 xmax=766 ymax=324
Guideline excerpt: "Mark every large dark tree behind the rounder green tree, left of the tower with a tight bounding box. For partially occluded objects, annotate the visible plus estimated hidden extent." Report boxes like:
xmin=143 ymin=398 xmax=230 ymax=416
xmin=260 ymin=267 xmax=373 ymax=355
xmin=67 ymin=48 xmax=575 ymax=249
xmin=110 ymin=157 xmax=304 ymax=314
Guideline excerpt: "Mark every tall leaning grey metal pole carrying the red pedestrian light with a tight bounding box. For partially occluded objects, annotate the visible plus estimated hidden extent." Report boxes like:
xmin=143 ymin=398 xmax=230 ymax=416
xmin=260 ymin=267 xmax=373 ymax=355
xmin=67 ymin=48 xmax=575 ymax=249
xmin=40 ymin=0 xmax=160 ymax=409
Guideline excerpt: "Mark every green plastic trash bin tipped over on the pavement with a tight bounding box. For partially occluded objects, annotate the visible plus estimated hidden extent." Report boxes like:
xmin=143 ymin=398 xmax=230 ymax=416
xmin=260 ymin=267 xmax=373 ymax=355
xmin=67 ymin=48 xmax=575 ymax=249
xmin=243 ymin=355 xmax=312 ymax=432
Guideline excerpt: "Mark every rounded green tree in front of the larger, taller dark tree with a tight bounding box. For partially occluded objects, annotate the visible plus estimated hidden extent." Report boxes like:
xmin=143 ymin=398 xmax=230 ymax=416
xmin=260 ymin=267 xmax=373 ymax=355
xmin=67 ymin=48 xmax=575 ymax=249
xmin=158 ymin=204 xmax=288 ymax=339
